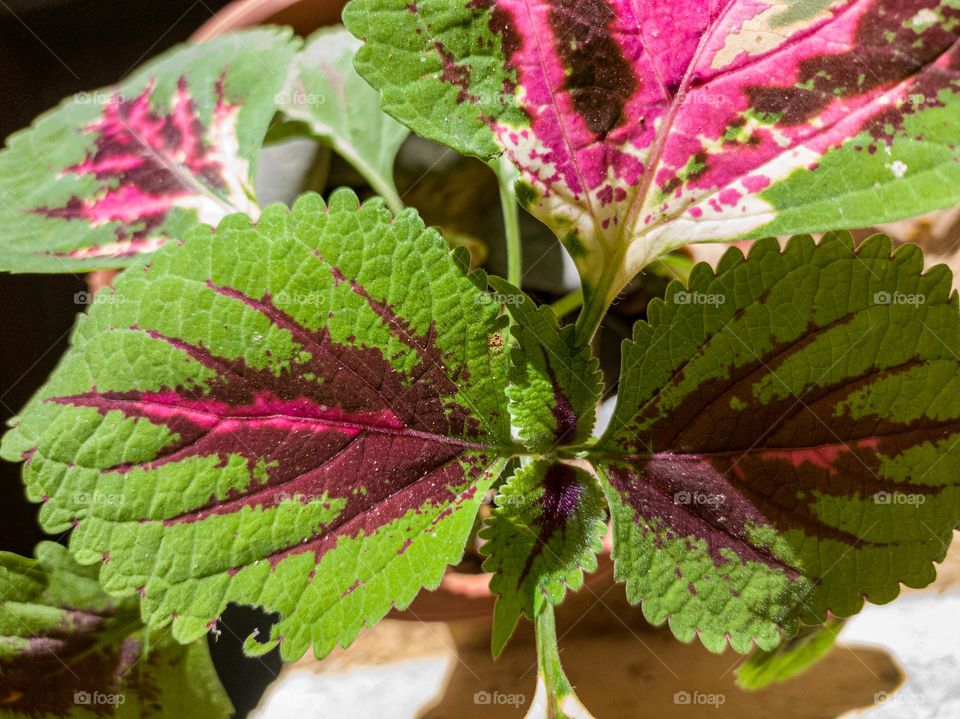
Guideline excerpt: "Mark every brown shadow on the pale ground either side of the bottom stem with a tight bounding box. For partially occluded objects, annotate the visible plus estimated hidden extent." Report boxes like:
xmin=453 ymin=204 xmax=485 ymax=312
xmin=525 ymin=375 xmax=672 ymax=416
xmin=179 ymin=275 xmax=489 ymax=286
xmin=421 ymin=588 xmax=902 ymax=719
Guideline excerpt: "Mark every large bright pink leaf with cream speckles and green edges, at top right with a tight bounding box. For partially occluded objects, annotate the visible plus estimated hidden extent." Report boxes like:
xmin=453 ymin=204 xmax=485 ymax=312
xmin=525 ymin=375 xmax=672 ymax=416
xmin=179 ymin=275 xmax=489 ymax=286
xmin=345 ymin=0 xmax=960 ymax=336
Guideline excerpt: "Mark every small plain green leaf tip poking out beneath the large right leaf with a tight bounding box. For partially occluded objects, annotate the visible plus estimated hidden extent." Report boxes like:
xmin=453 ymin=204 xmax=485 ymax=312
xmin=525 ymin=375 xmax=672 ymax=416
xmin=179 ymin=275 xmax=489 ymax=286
xmin=737 ymin=619 xmax=844 ymax=691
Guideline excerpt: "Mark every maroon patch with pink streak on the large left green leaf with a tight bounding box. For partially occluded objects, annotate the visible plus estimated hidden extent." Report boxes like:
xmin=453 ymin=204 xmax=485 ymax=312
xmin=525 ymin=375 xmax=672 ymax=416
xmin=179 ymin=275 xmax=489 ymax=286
xmin=49 ymin=282 xmax=490 ymax=563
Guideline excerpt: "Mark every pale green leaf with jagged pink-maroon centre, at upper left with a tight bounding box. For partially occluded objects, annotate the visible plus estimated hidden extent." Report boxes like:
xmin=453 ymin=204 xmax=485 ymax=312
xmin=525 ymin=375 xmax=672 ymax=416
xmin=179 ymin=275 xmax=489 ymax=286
xmin=0 ymin=29 xmax=298 ymax=272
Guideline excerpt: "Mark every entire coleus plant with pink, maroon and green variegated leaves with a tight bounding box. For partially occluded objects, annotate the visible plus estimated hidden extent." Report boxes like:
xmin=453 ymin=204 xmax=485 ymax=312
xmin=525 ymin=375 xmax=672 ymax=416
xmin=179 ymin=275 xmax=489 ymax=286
xmin=0 ymin=0 xmax=960 ymax=716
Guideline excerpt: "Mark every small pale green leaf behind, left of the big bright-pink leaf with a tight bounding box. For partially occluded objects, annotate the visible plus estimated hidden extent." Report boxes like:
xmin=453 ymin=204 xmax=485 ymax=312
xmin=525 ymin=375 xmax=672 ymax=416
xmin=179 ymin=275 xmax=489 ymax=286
xmin=280 ymin=28 xmax=410 ymax=212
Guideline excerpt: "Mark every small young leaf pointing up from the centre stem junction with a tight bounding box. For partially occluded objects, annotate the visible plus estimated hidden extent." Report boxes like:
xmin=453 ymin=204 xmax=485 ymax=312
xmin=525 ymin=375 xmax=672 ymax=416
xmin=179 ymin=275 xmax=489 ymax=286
xmin=489 ymin=277 xmax=603 ymax=454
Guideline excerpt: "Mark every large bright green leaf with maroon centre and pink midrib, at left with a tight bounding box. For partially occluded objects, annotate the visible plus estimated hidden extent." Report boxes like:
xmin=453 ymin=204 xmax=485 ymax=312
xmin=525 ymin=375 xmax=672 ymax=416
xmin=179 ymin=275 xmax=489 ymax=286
xmin=3 ymin=191 xmax=513 ymax=659
